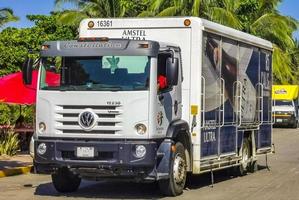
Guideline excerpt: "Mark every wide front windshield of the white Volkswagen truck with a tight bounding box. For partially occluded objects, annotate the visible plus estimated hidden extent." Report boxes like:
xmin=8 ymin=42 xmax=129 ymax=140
xmin=40 ymin=56 xmax=150 ymax=91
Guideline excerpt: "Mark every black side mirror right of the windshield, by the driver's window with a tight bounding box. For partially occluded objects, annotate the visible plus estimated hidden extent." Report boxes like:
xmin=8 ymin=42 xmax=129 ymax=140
xmin=166 ymin=58 xmax=179 ymax=86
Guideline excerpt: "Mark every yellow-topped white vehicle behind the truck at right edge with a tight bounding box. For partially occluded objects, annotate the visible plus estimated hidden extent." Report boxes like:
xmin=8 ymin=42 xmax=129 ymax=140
xmin=272 ymin=85 xmax=299 ymax=128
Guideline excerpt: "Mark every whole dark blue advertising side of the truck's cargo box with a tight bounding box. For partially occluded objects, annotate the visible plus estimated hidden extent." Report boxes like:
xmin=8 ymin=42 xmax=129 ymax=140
xmin=201 ymin=32 xmax=272 ymax=160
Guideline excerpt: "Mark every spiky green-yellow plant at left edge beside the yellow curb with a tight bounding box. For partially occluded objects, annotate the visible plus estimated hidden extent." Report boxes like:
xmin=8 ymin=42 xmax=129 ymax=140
xmin=0 ymin=130 xmax=19 ymax=156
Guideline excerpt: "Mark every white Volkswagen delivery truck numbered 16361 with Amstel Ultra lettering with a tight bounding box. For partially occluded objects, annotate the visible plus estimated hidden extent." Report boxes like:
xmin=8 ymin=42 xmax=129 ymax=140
xmin=23 ymin=17 xmax=273 ymax=196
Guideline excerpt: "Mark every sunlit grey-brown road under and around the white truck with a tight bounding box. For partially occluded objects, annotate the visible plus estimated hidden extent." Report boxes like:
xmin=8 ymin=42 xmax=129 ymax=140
xmin=0 ymin=129 xmax=299 ymax=200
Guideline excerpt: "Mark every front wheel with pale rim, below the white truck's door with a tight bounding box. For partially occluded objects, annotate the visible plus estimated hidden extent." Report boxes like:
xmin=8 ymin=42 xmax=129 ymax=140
xmin=158 ymin=142 xmax=187 ymax=196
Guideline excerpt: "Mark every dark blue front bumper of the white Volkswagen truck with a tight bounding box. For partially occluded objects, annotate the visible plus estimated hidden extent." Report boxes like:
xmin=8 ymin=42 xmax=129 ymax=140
xmin=34 ymin=139 xmax=158 ymax=178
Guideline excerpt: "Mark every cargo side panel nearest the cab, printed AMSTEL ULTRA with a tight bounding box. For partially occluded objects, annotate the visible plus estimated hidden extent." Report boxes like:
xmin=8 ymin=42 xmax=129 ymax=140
xmin=201 ymin=33 xmax=221 ymax=158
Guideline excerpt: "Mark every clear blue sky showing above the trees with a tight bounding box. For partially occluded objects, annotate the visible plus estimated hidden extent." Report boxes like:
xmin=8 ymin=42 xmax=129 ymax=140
xmin=0 ymin=0 xmax=299 ymax=39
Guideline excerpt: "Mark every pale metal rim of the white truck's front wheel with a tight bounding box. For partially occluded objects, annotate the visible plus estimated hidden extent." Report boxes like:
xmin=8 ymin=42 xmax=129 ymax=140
xmin=173 ymin=154 xmax=186 ymax=185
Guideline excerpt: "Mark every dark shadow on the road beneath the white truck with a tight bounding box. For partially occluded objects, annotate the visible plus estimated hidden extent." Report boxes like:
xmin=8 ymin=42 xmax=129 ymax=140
xmin=34 ymin=165 xmax=266 ymax=199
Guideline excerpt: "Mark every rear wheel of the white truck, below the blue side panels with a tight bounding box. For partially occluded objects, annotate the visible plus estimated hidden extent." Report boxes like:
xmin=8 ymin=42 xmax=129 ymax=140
xmin=238 ymin=138 xmax=252 ymax=176
